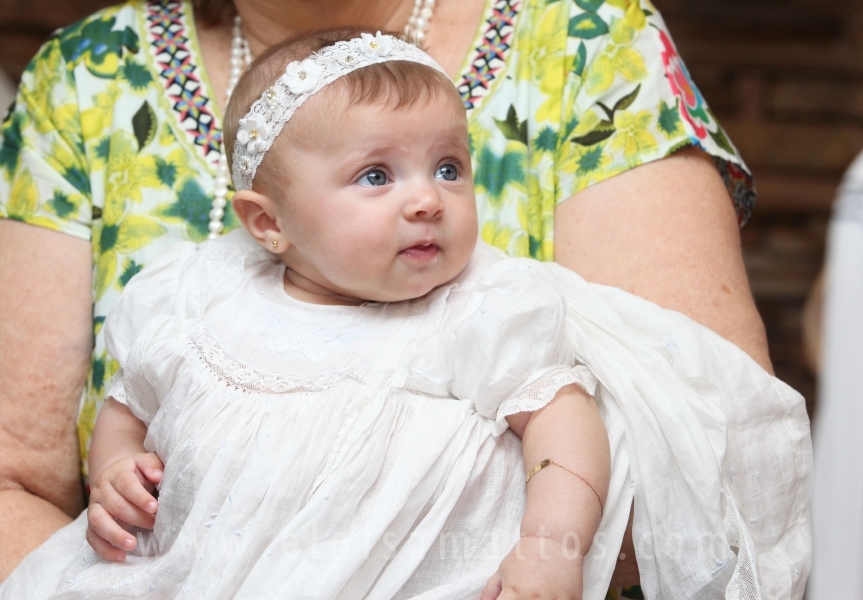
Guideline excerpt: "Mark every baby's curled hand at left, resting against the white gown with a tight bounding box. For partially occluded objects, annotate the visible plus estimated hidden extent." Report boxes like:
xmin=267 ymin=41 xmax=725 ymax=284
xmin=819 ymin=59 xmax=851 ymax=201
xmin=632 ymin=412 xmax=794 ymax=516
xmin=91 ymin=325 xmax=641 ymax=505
xmin=87 ymin=452 xmax=165 ymax=562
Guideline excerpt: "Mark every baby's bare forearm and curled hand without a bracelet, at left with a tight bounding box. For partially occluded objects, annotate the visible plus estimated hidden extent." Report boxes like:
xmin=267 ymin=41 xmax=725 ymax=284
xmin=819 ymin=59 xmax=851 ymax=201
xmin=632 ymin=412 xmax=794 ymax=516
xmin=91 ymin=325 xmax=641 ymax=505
xmin=87 ymin=398 xmax=164 ymax=562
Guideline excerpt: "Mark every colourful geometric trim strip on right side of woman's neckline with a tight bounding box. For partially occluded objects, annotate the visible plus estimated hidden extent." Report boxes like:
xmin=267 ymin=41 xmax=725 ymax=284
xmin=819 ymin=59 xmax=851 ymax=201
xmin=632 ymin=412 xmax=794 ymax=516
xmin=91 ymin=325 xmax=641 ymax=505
xmin=456 ymin=0 xmax=521 ymax=111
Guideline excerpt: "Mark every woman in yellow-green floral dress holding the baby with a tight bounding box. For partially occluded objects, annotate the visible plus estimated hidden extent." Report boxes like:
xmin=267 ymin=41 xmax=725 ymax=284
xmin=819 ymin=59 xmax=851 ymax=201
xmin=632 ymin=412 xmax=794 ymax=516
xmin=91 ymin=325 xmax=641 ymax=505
xmin=0 ymin=0 xmax=770 ymax=584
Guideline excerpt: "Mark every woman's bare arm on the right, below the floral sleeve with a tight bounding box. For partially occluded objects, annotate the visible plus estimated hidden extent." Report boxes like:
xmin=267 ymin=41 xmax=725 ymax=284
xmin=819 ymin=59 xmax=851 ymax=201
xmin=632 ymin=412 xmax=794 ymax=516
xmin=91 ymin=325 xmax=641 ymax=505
xmin=554 ymin=149 xmax=773 ymax=586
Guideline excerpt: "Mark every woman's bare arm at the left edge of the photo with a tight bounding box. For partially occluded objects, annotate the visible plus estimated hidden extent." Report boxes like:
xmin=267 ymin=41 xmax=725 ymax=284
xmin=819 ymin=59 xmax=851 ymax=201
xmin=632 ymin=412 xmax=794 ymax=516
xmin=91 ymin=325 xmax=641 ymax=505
xmin=0 ymin=219 xmax=93 ymax=580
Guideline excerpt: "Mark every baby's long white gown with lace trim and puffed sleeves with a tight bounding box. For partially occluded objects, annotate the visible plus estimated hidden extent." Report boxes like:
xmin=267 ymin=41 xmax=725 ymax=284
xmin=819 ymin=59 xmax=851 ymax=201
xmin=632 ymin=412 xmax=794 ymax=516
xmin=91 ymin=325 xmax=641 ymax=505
xmin=0 ymin=232 xmax=811 ymax=600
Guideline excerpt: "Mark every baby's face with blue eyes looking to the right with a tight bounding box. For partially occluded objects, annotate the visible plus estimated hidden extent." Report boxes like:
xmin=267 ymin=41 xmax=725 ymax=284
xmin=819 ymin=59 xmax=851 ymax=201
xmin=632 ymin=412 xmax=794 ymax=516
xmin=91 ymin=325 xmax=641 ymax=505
xmin=271 ymin=86 xmax=477 ymax=302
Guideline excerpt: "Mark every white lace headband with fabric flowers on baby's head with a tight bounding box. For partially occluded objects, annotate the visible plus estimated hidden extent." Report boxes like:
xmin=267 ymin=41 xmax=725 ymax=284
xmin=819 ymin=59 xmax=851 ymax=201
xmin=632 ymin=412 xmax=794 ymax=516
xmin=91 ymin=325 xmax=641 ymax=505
xmin=232 ymin=31 xmax=446 ymax=190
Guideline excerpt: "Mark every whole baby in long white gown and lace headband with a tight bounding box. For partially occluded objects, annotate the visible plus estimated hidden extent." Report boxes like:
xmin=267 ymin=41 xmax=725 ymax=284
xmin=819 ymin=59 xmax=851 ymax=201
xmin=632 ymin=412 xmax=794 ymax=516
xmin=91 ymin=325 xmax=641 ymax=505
xmin=0 ymin=25 xmax=811 ymax=600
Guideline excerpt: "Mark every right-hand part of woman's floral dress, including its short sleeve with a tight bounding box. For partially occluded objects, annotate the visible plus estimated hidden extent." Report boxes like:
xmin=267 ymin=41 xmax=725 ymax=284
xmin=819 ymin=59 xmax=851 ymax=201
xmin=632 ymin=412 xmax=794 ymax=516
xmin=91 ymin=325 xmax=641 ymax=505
xmin=466 ymin=0 xmax=754 ymax=261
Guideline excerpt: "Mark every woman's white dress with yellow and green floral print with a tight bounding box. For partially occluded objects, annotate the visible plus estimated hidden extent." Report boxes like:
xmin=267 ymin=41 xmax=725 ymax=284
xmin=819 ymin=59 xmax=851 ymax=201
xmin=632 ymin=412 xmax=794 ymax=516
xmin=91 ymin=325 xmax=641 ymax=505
xmin=0 ymin=0 xmax=754 ymax=475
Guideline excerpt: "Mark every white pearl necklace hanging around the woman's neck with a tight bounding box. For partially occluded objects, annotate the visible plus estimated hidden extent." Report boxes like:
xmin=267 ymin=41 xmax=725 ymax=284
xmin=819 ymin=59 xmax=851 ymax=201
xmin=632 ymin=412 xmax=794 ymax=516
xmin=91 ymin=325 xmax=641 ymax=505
xmin=208 ymin=0 xmax=436 ymax=239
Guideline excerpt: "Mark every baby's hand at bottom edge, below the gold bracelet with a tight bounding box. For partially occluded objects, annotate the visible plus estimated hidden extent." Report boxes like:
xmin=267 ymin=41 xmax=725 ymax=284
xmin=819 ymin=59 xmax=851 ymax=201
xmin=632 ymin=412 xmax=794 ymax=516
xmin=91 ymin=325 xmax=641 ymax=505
xmin=480 ymin=536 xmax=584 ymax=600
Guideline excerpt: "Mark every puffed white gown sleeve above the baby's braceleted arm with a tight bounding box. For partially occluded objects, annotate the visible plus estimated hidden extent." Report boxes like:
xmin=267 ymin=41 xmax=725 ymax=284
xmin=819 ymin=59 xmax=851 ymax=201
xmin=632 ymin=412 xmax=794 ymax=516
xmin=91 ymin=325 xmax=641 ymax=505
xmin=452 ymin=259 xmax=596 ymax=435
